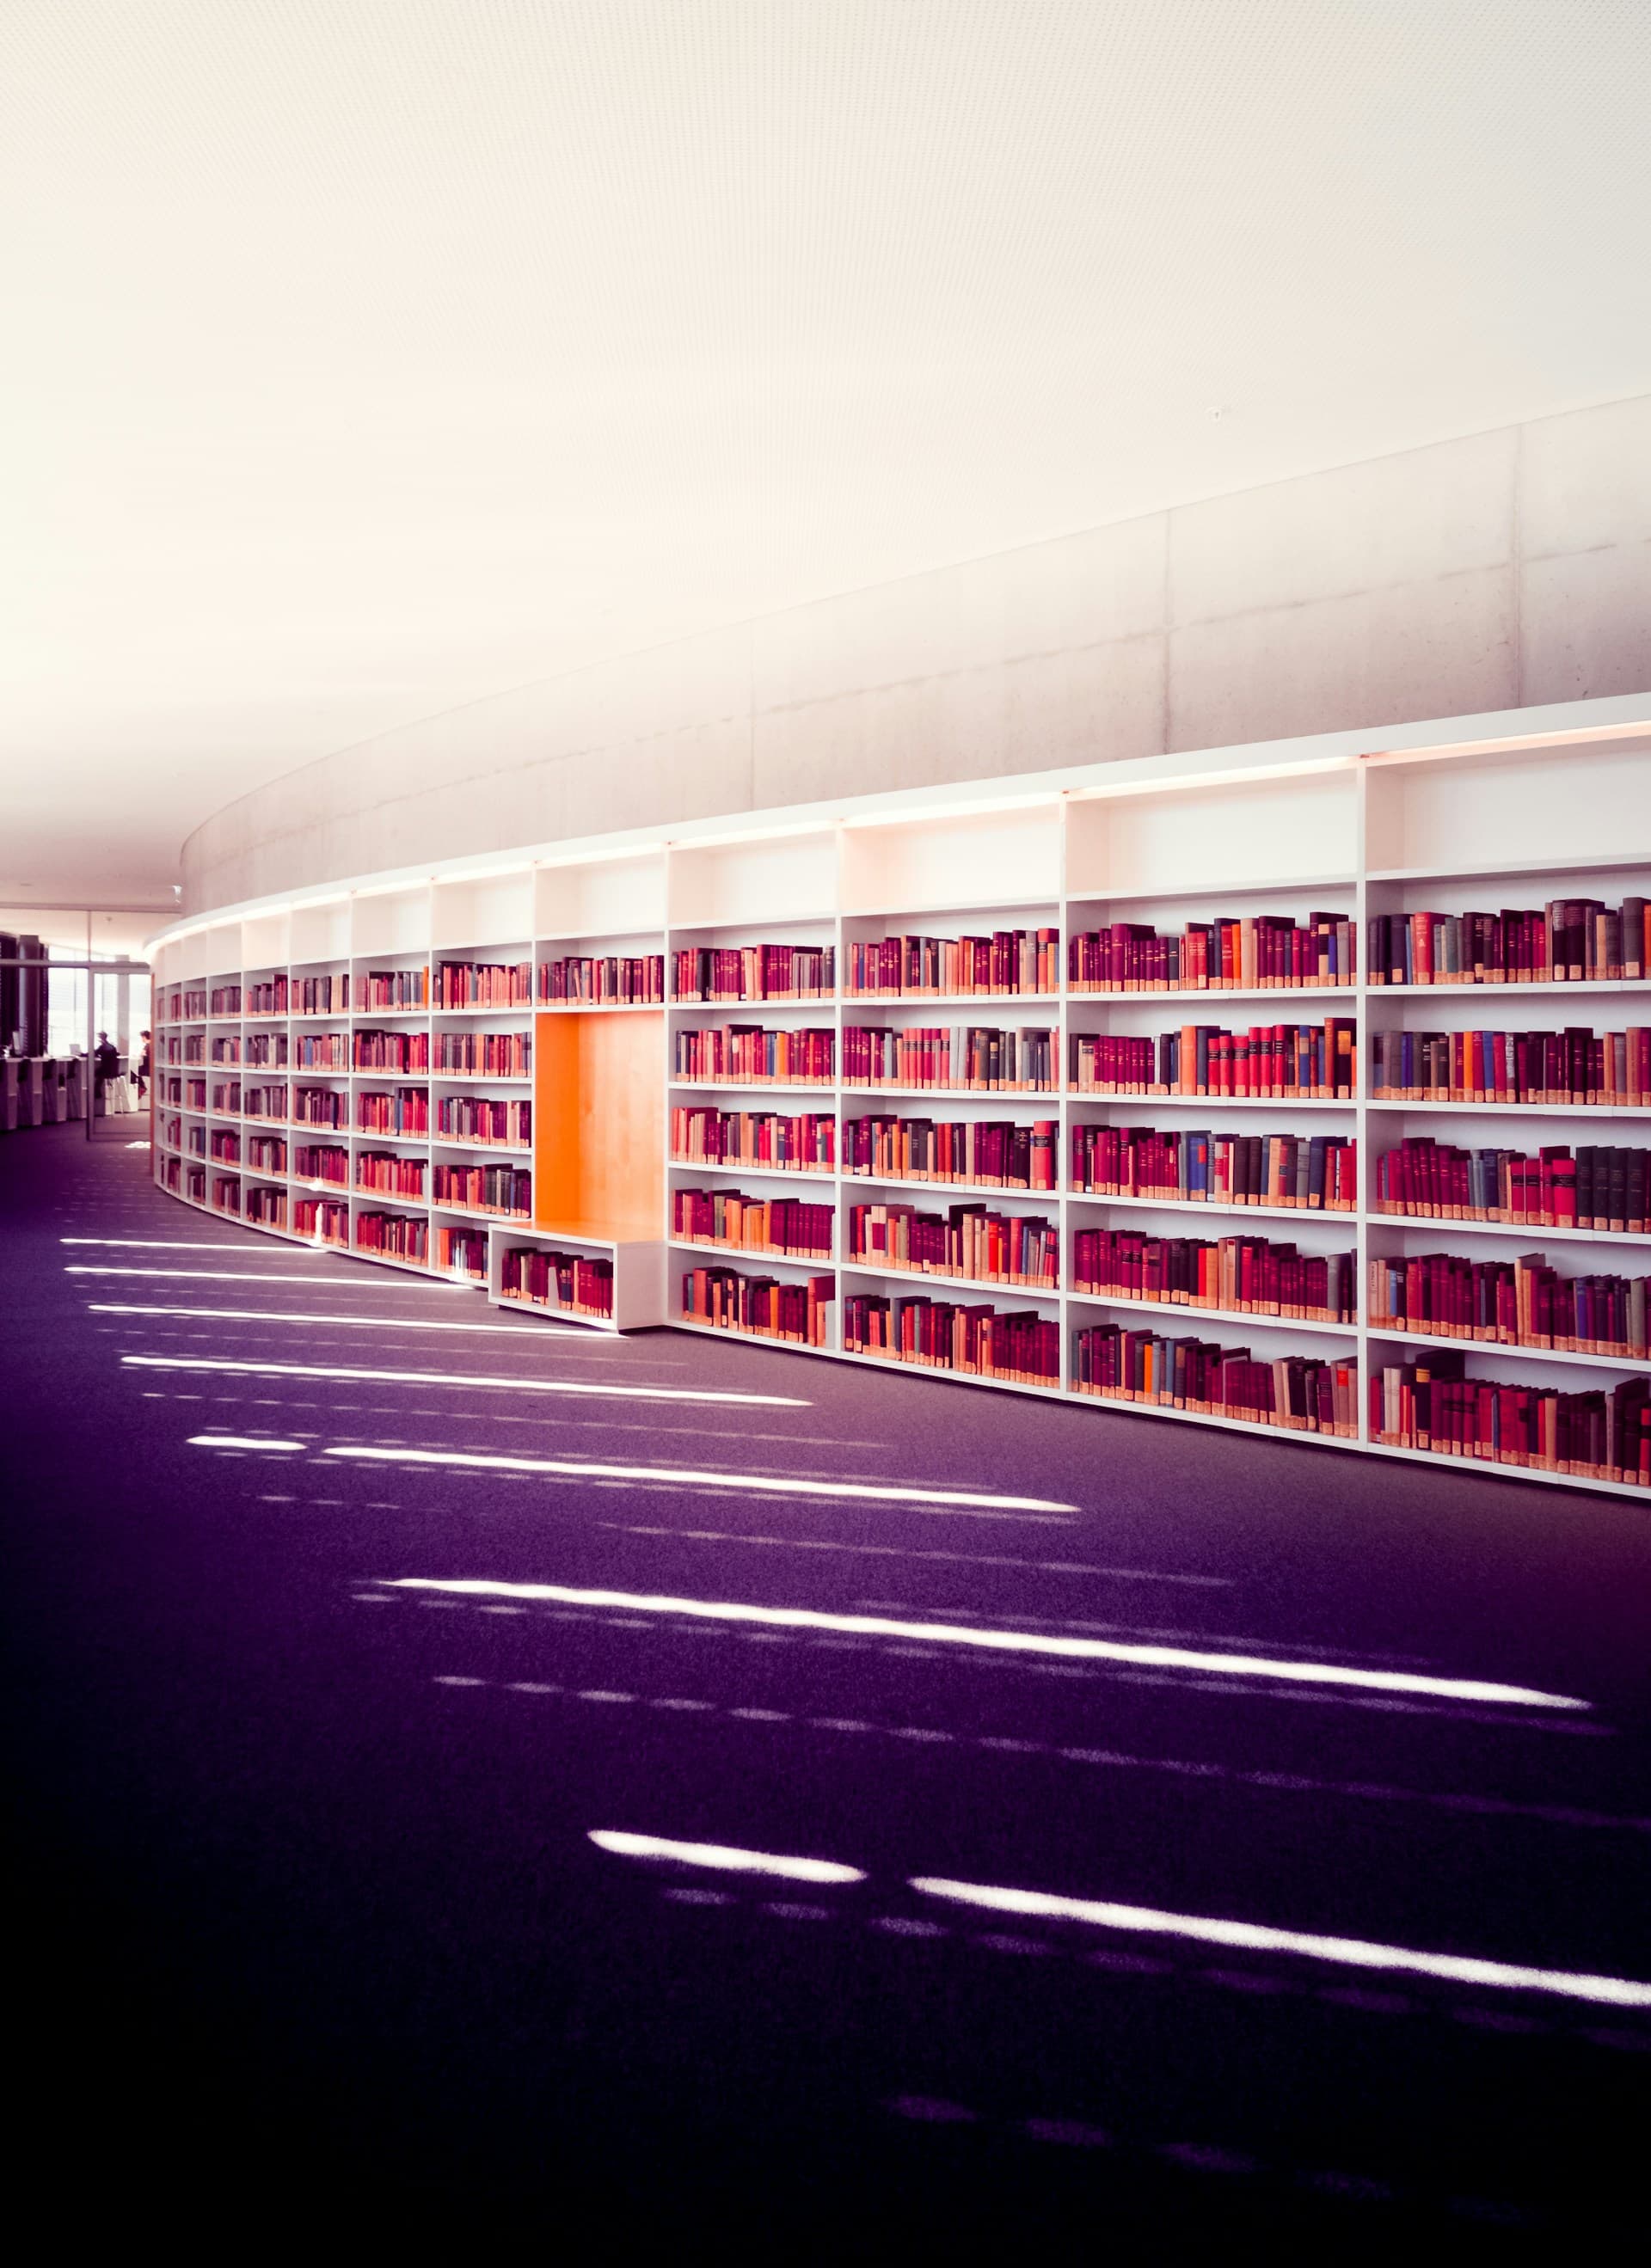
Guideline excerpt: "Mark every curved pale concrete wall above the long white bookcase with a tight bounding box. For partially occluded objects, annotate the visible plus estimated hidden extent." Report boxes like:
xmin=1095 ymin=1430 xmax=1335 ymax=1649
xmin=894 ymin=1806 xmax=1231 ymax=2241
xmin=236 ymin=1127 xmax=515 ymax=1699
xmin=184 ymin=395 xmax=1651 ymax=911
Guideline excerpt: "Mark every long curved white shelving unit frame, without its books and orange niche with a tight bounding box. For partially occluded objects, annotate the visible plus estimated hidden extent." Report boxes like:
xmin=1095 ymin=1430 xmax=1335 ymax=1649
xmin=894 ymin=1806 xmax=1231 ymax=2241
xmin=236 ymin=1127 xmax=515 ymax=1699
xmin=154 ymin=696 xmax=1651 ymax=1494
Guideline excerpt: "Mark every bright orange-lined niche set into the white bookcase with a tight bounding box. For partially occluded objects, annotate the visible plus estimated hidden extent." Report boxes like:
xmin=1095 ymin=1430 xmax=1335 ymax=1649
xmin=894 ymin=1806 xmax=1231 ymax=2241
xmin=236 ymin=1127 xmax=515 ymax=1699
xmin=533 ymin=1009 xmax=665 ymax=1238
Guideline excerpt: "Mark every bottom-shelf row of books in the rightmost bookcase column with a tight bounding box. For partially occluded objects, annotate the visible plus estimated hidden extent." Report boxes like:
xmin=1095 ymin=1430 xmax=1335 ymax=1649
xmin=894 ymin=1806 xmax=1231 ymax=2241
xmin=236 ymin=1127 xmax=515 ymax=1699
xmin=1370 ymin=1347 xmax=1651 ymax=1488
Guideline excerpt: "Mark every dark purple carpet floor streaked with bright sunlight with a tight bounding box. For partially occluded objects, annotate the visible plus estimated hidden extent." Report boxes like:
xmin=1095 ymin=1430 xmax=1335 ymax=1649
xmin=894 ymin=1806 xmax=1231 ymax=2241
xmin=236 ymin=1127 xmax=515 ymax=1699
xmin=0 ymin=1127 xmax=1651 ymax=2261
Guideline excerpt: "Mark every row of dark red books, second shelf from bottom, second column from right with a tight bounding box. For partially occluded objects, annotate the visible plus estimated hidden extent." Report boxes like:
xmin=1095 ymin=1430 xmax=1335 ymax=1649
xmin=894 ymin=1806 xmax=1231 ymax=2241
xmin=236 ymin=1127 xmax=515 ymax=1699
xmin=1072 ymin=1229 xmax=1359 ymax=1322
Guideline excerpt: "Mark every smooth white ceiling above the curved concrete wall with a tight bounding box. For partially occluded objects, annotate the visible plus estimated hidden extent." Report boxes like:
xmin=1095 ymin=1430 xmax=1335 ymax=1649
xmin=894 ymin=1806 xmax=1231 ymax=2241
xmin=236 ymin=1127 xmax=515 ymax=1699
xmin=0 ymin=0 xmax=1651 ymax=903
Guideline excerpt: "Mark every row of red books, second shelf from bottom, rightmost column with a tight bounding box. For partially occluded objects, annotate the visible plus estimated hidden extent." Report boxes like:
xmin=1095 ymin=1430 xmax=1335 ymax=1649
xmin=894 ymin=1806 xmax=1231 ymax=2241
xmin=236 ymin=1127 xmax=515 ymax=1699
xmin=1367 ymin=1252 xmax=1651 ymax=1357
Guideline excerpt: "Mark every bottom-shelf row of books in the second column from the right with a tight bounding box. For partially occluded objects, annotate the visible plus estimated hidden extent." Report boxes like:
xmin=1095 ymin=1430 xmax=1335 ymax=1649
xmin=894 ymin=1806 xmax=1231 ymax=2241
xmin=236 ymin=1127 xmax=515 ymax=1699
xmin=1072 ymin=1322 xmax=1359 ymax=1440
